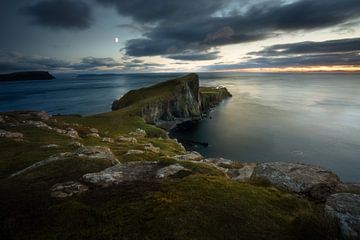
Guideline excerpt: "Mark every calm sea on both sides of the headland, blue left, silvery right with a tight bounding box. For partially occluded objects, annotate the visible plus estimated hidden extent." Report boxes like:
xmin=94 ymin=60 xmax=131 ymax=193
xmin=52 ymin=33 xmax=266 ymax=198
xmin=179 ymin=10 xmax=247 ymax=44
xmin=0 ymin=73 xmax=360 ymax=182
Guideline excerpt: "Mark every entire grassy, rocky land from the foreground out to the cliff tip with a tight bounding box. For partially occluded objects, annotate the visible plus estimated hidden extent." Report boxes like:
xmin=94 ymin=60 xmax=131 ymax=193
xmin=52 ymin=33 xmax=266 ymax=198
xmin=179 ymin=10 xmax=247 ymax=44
xmin=0 ymin=74 xmax=360 ymax=240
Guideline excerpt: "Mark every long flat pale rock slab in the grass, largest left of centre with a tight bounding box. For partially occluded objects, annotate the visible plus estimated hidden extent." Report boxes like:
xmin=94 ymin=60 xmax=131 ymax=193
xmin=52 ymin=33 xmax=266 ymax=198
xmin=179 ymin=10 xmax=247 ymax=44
xmin=82 ymin=162 xmax=159 ymax=187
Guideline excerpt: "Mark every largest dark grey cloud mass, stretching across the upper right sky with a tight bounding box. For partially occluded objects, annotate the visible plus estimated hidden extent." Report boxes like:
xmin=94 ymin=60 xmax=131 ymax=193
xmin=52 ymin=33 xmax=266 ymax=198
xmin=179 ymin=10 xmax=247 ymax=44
xmin=103 ymin=0 xmax=360 ymax=60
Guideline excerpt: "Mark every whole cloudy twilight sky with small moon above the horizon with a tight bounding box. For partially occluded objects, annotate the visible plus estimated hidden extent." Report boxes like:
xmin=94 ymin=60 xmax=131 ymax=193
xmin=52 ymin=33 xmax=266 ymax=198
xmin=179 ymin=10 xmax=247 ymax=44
xmin=0 ymin=0 xmax=360 ymax=73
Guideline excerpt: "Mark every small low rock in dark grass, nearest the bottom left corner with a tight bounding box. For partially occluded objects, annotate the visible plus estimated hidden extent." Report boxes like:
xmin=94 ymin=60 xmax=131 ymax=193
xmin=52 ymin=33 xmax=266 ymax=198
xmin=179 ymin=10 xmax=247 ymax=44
xmin=50 ymin=181 xmax=89 ymax=198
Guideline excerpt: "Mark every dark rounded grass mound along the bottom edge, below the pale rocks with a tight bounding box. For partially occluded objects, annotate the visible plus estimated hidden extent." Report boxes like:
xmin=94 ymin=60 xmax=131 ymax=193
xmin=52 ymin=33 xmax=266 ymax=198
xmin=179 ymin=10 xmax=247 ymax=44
xmin=1 ymin=174 xmax=339 ymax=240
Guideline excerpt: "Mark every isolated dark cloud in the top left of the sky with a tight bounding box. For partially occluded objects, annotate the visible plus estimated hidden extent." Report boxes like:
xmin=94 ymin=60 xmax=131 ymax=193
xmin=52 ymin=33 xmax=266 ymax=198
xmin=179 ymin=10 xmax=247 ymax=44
xmin=21 ymin=0 xmax=93 ymax=30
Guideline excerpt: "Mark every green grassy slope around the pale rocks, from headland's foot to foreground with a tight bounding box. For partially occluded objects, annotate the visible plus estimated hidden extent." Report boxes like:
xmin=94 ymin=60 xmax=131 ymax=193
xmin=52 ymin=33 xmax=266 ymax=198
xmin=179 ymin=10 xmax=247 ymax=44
xmin=0 ymin=75 xmax=338 ymax=239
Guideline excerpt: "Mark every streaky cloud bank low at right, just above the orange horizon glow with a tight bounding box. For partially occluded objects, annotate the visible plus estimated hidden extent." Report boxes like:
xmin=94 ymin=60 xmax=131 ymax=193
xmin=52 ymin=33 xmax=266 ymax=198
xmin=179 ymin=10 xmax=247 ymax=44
xmin=207 ymin=38 xmax=360 ymax=70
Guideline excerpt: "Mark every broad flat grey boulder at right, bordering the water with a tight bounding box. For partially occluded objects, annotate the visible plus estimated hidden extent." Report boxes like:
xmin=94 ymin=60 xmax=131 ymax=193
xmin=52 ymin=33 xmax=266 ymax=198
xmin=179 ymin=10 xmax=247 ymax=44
xmin=253 ymin=162 xmax=340 ymax=201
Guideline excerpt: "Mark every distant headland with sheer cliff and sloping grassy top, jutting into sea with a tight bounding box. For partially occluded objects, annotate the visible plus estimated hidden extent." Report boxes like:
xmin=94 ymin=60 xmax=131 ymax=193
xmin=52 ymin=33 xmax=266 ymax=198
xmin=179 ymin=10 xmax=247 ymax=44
xmin=112 ymin=74 xmax=231 ymax=128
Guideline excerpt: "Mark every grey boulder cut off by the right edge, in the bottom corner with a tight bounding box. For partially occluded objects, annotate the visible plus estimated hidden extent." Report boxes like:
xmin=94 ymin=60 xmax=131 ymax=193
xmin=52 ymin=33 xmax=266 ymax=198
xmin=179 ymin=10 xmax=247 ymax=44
xmin=325 ymin=193 xmax=360 ymax=238
